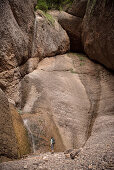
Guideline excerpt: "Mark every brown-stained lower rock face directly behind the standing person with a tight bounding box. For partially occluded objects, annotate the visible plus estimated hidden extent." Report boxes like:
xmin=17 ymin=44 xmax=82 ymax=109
xmin=22 ymin=111 xmax=65 ymax=154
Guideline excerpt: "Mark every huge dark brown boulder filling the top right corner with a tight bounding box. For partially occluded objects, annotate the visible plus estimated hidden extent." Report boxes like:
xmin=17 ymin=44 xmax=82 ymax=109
xmin=82 ymin=0 xmax=114 ymax=70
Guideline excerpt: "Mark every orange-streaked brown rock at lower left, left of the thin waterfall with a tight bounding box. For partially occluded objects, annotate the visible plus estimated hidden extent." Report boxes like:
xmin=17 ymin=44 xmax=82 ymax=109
xmin=0 ymin=89 xmax=30 ymax=161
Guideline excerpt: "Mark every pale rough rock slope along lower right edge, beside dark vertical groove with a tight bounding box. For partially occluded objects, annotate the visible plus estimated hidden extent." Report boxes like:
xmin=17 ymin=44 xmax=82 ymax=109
xmin=76 ymin=69 xmax=114 ymax=169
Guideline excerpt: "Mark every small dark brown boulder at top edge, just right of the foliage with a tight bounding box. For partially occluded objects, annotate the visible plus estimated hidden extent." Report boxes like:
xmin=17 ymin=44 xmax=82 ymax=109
xmin=67 ymin=0 xmax=87 ymax=18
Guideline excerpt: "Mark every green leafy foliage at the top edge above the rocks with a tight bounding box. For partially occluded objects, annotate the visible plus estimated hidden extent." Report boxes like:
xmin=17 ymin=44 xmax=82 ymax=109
xmin=35 ymin=0 xmax=73 ymax=12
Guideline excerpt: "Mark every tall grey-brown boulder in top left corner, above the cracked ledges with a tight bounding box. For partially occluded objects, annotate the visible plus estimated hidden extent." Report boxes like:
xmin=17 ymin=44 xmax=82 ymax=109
xmin=0 ymin=0 xmax=34 ymax=72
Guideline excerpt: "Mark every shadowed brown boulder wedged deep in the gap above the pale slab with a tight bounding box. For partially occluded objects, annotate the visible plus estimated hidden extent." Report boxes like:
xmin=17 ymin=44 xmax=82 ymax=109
xmin=50 ymin=11 xmax=83 ymax=52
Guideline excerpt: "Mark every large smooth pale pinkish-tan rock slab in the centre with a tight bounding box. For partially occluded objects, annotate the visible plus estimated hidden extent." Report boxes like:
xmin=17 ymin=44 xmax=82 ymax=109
xmin=15 ymin=54 xmax=114 ymax=157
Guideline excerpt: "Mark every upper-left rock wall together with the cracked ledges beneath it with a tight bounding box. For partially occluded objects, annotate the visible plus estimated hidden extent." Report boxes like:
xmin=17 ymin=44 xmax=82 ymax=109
xmin=0 ymin=0 xmax=38 ymax=96
